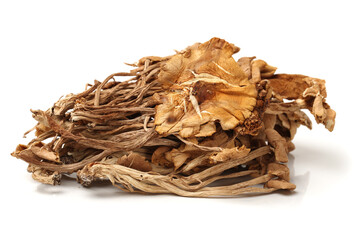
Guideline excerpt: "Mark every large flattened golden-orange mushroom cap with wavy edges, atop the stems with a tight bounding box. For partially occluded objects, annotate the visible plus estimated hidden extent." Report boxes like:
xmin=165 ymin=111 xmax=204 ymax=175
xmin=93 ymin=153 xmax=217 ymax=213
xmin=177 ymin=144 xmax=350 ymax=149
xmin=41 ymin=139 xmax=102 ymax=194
xmin=155 ymin=38 xmax=257 ymax=137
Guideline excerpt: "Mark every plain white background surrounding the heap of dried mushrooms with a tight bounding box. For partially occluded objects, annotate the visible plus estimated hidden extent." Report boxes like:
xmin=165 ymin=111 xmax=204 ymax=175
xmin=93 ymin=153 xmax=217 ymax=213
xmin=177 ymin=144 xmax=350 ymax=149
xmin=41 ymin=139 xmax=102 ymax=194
xmin=0 ymin=0 xmax=360 ymax=240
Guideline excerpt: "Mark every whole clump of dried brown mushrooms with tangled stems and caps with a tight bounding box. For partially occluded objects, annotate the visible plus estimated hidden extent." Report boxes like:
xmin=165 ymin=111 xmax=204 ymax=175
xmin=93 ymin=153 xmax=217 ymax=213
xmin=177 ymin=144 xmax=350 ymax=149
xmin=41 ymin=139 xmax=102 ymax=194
xmin=12 ymin=38 xmax=336 ymax=197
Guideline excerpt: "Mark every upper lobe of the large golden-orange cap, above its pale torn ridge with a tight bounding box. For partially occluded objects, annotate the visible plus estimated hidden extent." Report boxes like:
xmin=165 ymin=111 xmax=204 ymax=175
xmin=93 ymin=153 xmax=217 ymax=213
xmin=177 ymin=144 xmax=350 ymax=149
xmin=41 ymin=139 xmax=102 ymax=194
xmin=158 ymin=38 xmax=247 ymax=87
